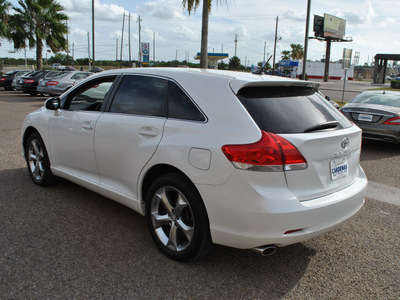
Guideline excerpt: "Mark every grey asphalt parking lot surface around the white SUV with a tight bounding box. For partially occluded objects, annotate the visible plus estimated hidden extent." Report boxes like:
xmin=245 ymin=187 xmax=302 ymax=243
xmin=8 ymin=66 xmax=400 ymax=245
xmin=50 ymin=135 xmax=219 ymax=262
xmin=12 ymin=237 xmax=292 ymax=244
xmin=0 ymin=90 xmax=400 ymax=299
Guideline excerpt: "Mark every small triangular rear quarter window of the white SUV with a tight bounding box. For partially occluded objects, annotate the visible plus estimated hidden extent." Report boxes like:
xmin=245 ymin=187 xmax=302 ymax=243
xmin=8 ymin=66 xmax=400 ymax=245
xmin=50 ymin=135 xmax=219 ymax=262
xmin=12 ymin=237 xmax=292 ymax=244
xmin=168 ymin=82 xmax=206 ymax=122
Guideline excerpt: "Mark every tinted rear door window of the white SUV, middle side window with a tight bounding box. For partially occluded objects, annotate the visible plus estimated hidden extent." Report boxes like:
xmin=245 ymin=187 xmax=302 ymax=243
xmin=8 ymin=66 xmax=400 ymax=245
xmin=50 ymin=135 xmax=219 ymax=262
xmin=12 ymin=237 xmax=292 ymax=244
xmin=110 ymin=75 xmax=168 ymax=117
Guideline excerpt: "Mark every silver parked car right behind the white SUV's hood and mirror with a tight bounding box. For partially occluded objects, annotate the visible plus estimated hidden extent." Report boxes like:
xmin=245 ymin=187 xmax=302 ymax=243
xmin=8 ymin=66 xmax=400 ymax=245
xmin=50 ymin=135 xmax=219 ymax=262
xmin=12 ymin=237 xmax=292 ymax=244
xmin=43 ymin=71 xmax=93 ymax=96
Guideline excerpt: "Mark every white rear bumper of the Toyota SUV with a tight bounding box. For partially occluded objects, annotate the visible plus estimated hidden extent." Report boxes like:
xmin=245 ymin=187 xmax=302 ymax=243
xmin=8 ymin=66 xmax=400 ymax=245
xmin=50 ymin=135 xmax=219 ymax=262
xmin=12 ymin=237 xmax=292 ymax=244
xmin=197 ymin=168 xmax=367 ymax=249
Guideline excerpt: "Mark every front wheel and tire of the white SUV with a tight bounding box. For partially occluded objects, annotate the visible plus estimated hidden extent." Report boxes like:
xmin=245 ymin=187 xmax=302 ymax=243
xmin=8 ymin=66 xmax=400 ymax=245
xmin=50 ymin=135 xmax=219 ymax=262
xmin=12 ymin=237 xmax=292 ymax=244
xmin=25 ymin=132 xmax=55 ymax=186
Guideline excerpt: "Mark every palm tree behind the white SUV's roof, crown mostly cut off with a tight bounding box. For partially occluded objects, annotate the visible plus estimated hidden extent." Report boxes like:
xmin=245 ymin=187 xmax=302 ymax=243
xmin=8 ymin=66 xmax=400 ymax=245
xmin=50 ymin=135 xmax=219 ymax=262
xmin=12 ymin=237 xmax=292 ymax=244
xmin=182 ymin=0 xmax=226 ymax=69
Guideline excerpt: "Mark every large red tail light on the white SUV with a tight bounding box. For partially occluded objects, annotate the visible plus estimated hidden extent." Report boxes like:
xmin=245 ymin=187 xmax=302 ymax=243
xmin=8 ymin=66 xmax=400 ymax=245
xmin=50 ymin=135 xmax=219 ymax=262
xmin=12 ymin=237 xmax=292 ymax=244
xmin=221 ymin=131 xmax=307 ymax=172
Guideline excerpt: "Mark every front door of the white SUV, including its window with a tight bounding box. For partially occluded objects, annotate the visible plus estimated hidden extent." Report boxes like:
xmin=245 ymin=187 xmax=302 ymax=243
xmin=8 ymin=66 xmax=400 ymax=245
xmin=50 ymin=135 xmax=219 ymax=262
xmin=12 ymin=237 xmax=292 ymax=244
xmin=49 ymin=76 xmax=116 ymax=184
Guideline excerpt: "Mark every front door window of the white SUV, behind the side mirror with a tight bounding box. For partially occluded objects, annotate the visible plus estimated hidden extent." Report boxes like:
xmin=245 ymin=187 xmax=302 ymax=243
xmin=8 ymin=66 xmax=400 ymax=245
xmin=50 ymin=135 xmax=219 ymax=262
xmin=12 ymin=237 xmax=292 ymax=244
xmin=64 ymin=77 xmax=115 ymax=111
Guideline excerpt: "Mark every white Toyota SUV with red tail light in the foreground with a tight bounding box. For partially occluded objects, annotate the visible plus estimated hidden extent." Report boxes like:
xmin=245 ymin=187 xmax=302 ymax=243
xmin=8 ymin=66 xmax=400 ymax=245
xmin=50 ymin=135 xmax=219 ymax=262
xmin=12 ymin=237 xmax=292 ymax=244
xmin=22 ymin=68 xmax=367 ymax=261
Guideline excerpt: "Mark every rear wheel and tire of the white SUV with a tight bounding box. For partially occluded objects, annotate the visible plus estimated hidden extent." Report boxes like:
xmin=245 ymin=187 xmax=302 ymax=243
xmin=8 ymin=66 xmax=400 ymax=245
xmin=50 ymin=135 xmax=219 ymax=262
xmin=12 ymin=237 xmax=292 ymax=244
xmin=146 ymin=173 xmax=212 ymax=261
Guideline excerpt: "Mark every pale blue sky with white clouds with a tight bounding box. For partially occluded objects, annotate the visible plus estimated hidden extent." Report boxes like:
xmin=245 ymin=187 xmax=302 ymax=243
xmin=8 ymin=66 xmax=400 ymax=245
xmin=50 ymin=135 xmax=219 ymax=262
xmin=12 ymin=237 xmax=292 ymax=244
xmin=0 ymin=0 xmax=400 ymax=65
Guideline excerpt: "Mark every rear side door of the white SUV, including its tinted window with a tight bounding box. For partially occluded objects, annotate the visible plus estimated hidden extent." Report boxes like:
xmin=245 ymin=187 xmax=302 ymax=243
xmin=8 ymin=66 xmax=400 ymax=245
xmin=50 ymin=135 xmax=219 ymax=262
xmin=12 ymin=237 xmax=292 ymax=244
xmin=94 ymin=75 xmax=168 ymax=199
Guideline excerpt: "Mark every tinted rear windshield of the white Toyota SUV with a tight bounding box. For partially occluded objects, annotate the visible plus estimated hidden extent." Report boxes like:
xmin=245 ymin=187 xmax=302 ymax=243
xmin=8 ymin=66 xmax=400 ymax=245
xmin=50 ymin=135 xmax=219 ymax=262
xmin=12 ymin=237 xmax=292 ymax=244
xmin=238 ymin=87 xmax=351 ymax=133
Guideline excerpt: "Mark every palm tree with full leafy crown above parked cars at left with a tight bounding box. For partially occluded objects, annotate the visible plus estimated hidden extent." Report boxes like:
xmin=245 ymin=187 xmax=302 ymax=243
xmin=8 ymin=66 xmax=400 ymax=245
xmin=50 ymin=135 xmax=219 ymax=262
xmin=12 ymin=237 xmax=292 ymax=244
xmin=10 ymin=0 xmax=68 ymax=70
